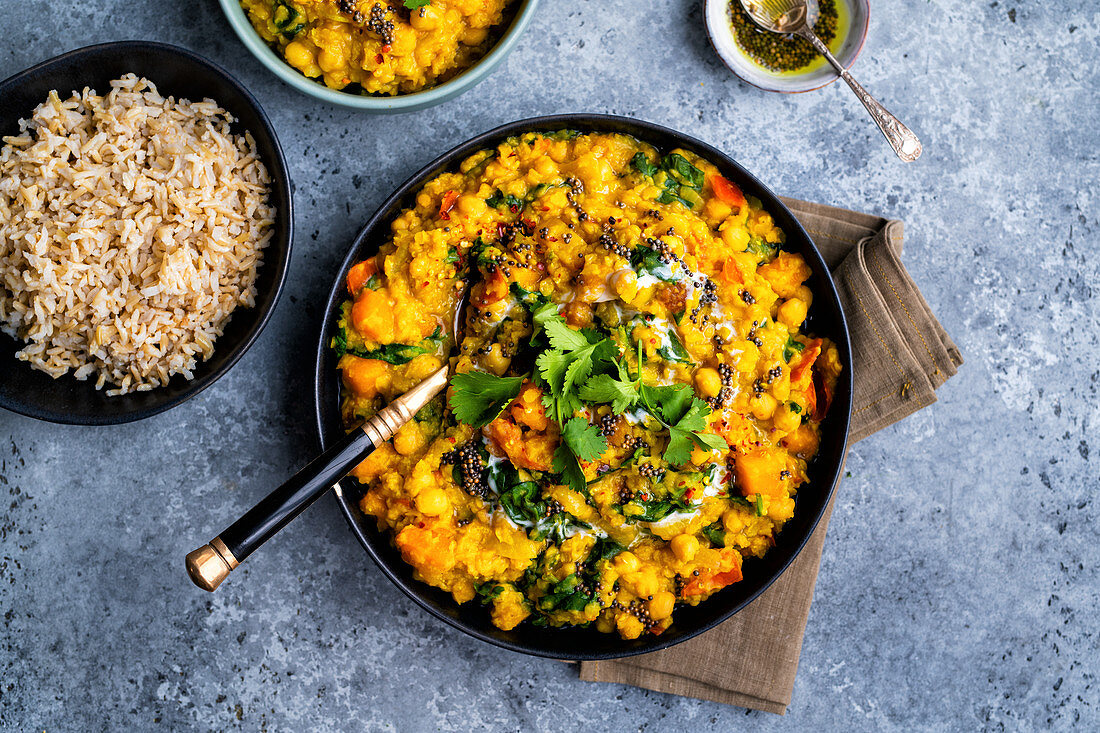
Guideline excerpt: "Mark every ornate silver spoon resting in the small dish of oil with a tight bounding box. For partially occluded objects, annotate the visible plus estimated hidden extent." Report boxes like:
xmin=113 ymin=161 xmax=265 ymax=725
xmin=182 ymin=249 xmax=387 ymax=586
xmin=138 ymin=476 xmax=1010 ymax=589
xmin=740 ymin=0 xmax=924 ymax=163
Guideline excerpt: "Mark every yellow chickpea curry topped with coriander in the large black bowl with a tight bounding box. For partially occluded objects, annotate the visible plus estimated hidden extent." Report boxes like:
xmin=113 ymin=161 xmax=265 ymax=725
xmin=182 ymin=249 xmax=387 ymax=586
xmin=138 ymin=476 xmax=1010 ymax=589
xmin=333 ymin=132 xmax=842 ymax=638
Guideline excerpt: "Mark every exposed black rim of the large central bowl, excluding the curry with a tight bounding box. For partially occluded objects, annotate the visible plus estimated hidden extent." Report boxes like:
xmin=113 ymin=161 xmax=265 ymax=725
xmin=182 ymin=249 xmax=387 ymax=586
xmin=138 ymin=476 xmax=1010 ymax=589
xmin=316 ymin=114 xmax=851 ymax=660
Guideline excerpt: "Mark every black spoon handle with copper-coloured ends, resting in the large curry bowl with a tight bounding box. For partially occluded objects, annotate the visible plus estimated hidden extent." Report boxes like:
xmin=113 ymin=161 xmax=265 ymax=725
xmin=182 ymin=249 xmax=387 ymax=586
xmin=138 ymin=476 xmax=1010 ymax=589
xmin=187 ymin=367 xmax=447 ymax=591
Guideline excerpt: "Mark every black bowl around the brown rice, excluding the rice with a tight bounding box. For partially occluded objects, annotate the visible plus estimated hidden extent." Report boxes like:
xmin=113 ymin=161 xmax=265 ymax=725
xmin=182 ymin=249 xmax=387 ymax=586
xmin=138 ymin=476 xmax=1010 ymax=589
xmin=0 ymin=41 xmax=294 ymax=425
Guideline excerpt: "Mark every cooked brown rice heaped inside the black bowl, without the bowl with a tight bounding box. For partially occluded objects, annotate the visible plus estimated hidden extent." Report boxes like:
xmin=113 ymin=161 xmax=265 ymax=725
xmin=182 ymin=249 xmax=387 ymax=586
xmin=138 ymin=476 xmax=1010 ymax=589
xmin=0 ymin=74 xmax=275 ymax=395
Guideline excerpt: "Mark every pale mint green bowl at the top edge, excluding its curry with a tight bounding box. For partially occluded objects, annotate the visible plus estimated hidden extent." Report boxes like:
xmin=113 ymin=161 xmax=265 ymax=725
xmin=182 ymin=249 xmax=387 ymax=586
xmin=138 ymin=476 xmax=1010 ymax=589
xmin=218 ymin=0 xmax=539 ymax=114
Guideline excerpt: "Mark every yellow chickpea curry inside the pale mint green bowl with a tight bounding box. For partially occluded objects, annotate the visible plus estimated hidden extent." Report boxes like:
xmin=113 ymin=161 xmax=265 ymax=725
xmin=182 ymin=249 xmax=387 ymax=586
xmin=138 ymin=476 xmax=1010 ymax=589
xmin=241 ymin=0 xmax=512 ymax=95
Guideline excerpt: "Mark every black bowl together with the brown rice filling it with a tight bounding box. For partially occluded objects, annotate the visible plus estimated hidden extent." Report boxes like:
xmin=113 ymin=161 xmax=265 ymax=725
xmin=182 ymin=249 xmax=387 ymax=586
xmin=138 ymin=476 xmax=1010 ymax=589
xmin=0 ymin=41 xmax=293 ymax=425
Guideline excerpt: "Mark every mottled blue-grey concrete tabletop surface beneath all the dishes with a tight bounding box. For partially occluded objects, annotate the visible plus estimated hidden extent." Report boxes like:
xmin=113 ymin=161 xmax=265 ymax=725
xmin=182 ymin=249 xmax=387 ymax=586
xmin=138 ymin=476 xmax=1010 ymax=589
xmin=0 ymin=0 xmax=1100 ymax=732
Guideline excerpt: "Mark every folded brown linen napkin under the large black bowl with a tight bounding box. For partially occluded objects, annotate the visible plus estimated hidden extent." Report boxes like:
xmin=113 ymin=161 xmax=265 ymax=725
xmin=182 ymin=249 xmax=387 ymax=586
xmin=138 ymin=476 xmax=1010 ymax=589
xmin=581 ymin=199 xmax=963 ymax=714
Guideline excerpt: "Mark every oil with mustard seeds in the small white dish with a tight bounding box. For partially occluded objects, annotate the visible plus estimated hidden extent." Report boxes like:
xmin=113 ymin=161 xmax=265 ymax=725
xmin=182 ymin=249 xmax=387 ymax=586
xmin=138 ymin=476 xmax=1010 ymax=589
xmin=729 ymin=0 xmax=851 ymax=76
